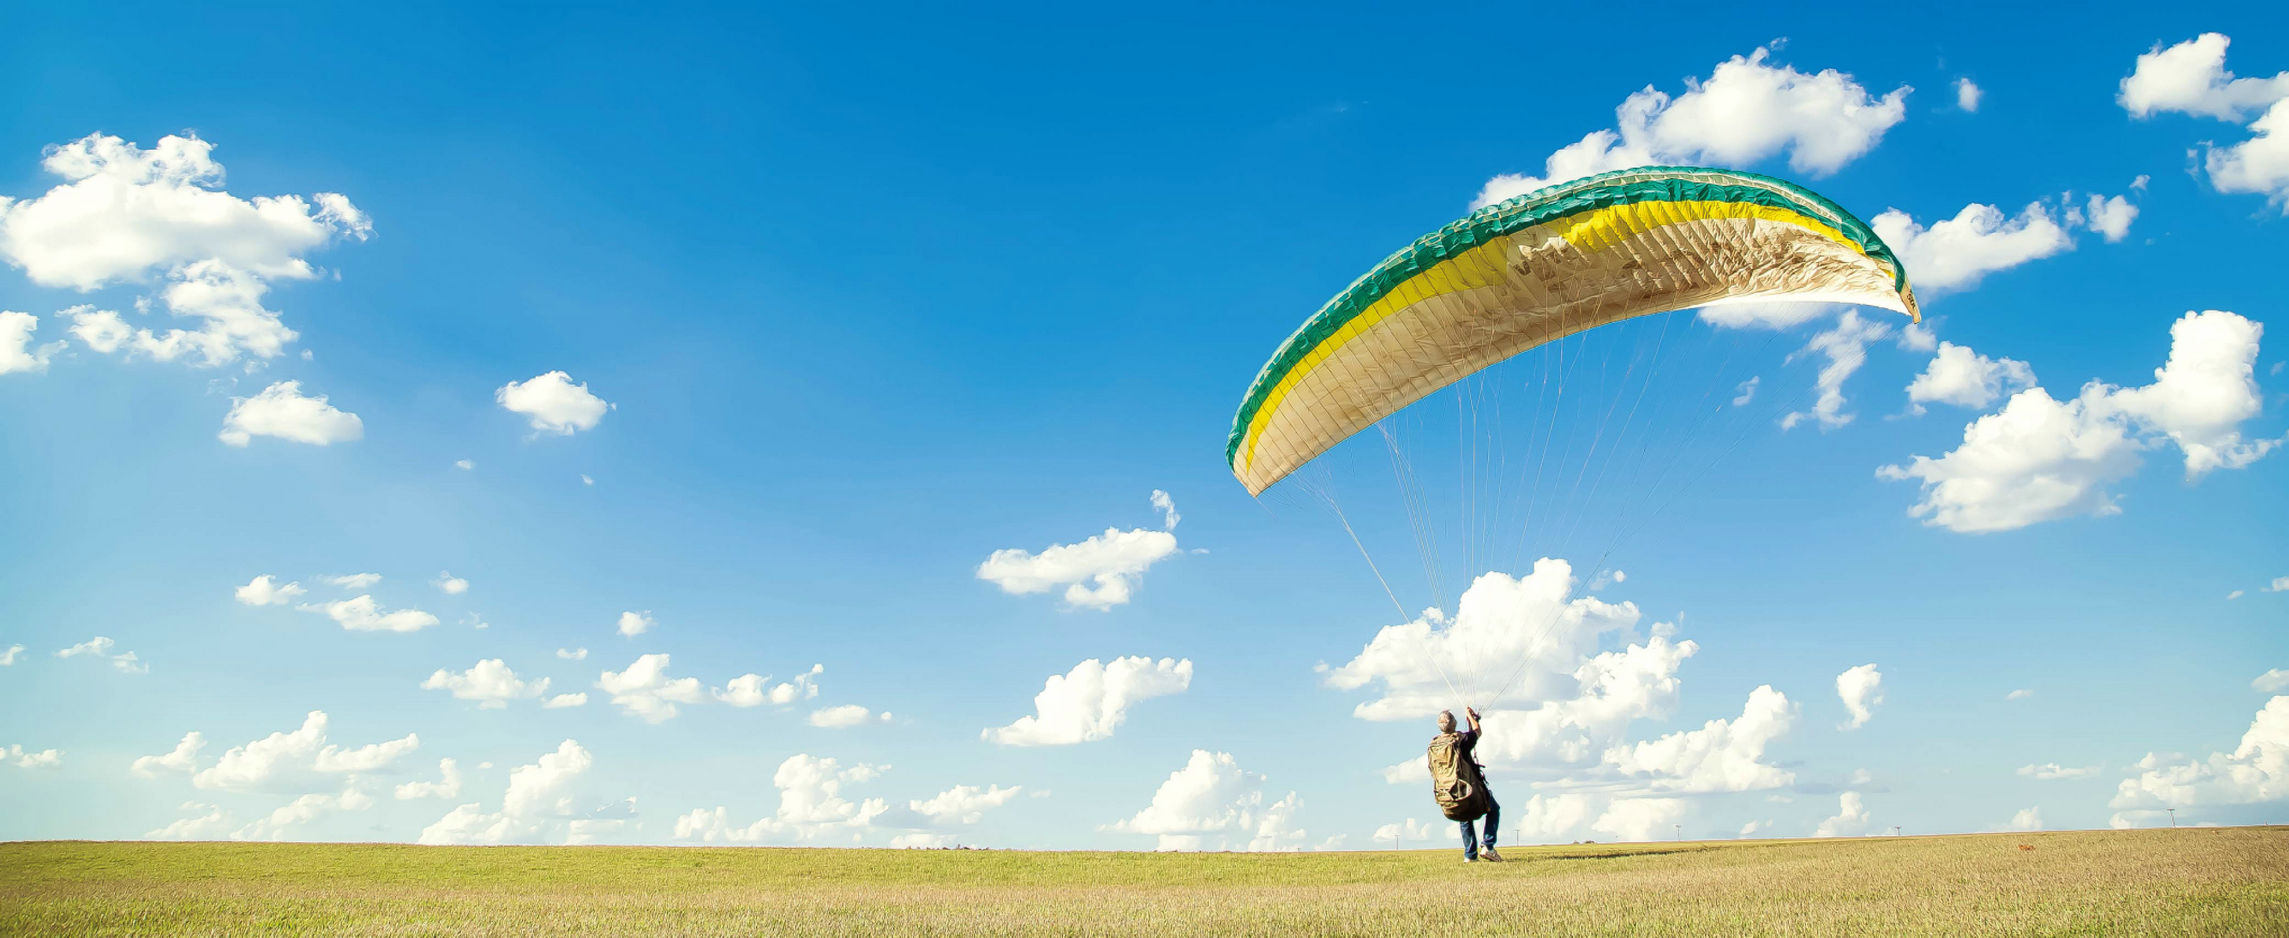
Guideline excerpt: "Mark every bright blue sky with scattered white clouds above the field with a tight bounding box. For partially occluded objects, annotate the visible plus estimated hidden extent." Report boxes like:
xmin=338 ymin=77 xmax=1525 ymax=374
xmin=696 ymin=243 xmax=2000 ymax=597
xmin=0 ymin=5 xmax=2289 ymax=849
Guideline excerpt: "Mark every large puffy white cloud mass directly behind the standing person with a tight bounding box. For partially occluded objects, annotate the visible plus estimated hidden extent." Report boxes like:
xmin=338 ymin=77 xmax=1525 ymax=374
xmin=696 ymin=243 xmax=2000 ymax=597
xmin=1328 ymin=558 xmax=1799 ymax=814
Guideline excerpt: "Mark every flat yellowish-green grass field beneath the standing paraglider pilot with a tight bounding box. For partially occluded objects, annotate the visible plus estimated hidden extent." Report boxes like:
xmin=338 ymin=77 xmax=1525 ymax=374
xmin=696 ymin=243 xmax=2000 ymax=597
xmin=0 ymin=828 xmax=2289 ymax=936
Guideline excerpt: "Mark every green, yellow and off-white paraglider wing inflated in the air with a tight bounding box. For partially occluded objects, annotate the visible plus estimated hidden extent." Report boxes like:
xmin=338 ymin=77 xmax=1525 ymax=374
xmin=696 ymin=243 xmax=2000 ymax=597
xmin=1225 ymin=167 xmax=1920 ymax=494
